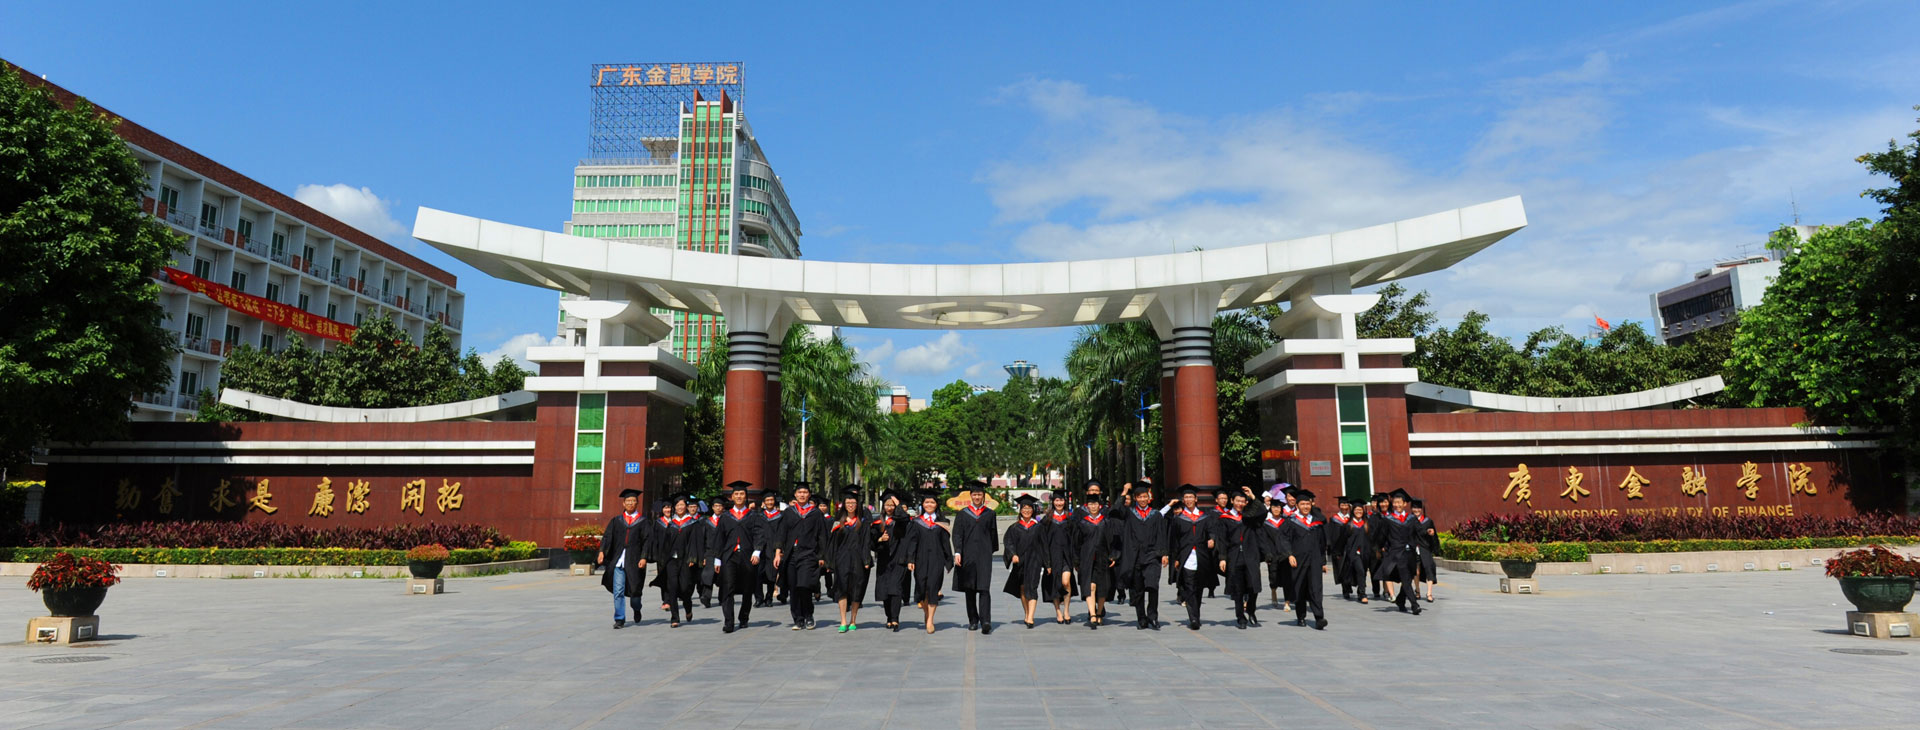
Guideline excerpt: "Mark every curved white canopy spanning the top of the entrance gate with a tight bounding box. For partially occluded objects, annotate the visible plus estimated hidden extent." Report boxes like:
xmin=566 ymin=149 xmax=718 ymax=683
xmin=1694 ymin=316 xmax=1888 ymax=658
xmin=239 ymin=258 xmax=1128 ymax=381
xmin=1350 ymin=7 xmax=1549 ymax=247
xmin=413 ymin=196 xmax=1526 ymax=329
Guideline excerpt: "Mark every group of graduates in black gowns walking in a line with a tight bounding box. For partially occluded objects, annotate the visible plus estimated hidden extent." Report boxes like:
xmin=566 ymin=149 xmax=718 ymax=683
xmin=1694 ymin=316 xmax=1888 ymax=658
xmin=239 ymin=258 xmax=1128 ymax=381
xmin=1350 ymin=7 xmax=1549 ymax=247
xmin=599 ymin=482 xmax=1438 ymax=634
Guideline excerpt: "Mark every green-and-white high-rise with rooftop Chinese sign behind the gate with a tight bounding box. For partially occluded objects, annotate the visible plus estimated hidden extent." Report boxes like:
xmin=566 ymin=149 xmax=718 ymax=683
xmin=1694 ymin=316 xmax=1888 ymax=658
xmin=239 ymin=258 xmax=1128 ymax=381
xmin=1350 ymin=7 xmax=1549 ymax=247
xmin=559 ymin=63 xmax=801 ymax=363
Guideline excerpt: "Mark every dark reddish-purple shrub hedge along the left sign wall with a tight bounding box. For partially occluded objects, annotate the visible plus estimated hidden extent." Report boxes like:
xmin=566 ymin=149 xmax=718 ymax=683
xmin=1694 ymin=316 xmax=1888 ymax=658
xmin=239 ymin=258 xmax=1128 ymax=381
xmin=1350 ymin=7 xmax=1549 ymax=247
xmin=0 ymin=521 xmax=509 ymax=549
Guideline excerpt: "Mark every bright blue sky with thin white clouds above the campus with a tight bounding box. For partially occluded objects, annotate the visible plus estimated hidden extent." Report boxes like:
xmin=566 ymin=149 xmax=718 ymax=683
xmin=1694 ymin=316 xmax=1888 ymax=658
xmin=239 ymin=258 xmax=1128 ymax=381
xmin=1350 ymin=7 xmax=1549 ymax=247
xmin=0 ymin=2 xmax=1920 ymax=396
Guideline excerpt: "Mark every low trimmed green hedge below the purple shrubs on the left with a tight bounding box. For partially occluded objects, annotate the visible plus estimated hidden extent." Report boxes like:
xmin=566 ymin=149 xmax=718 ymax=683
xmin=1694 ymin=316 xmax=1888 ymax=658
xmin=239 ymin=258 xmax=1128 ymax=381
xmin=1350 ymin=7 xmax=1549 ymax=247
xmin=0 ymin=542 xmax=540 ymax=565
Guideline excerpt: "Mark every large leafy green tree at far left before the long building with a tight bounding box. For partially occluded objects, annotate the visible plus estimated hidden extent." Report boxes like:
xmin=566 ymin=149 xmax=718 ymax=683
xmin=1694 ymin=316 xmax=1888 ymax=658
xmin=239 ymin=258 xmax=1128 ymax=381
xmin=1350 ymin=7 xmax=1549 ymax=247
xmin=0 ymin=63 xmax=180 ymax=465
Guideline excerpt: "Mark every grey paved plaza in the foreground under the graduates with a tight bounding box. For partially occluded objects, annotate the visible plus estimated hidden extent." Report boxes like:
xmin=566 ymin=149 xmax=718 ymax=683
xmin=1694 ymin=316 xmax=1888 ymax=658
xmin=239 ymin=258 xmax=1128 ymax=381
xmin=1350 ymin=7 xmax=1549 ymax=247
xmin=0 ymin=571 xmax=1920 ymax=730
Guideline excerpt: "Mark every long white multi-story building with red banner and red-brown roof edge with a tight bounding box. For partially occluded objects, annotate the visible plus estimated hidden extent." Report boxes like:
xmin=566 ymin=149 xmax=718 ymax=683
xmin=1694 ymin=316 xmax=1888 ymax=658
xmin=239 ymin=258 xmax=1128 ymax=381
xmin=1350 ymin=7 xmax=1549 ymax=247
xmin=21 ymin=71 xmax=467 ymax=421
